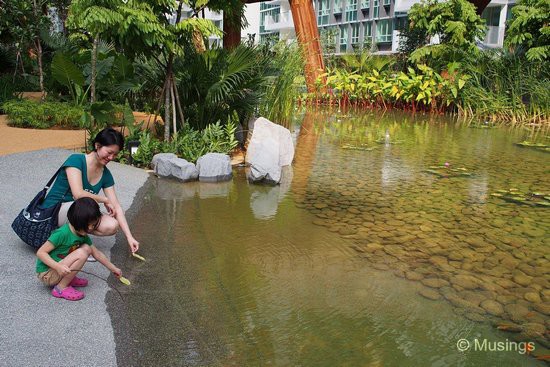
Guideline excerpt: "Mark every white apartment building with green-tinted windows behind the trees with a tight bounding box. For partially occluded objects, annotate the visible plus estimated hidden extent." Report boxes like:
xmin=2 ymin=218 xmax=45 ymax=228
xmin=259 ymin=0 xmax=514 ymax=54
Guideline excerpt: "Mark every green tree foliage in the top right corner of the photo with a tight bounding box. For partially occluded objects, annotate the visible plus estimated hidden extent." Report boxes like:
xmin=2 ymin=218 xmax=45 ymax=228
xmin=505 ymin=0 xmax=550 ymax=61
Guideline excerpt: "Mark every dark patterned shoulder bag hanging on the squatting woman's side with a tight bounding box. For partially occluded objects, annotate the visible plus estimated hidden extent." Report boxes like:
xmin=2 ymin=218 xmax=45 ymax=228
xmin=11 ymin=167 xmax=65 ymax=249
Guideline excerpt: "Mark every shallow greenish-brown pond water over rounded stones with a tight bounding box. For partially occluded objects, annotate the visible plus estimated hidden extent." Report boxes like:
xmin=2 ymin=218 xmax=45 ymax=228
xmin=107 ymin=111 xmax=550 ymax=366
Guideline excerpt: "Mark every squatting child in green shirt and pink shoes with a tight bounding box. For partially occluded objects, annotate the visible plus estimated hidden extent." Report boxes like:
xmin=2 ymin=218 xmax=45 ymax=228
xmin=36 ymin=197 xmax=122 ymax=301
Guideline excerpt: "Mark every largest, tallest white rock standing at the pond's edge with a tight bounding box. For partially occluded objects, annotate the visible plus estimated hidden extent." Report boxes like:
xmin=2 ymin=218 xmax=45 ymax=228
xmin=246 ymin=117 xmax=294 ymax=184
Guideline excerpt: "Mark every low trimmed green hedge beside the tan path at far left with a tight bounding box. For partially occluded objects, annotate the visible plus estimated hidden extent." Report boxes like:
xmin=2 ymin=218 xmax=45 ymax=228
xmin=2 ymin=100 xmax=83 ymax=129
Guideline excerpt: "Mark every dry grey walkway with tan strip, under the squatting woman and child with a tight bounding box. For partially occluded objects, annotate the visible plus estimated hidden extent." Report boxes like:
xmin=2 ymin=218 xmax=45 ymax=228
xmin=0 ymin=146 xmax=149 ymax=367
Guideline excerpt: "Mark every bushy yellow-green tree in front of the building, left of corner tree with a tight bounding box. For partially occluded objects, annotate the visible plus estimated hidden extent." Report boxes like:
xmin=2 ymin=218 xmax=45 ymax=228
xmin=403 ymin=0 xmax=486 ymax=67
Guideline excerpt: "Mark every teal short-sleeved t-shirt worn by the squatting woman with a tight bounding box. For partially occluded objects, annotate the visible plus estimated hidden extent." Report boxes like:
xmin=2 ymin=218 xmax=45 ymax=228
xmin=42 ymin=154 xmax=115 ymax=208
